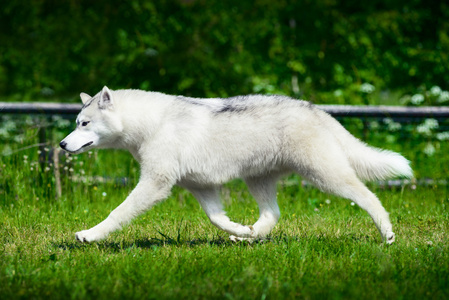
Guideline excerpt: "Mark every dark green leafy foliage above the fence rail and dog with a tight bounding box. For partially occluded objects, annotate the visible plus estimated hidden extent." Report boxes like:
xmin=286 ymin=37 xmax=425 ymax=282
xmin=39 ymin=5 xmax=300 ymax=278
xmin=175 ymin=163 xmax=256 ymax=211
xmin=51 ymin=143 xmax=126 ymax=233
xmin=0 ymin=0 xmax=449 ymax=103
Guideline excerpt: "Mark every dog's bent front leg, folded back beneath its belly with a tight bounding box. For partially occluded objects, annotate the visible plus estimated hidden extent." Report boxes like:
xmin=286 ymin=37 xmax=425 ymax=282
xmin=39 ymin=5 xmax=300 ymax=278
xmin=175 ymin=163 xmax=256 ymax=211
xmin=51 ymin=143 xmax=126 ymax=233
xmin=190 ymin=188 xmax=255 ymax=238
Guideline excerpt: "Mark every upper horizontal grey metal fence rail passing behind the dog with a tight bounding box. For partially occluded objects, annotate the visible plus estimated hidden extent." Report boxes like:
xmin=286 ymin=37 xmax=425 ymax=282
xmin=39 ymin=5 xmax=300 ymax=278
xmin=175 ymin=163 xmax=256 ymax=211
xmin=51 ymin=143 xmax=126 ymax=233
xmin=0 ymin=102 xmax=449 ymax=119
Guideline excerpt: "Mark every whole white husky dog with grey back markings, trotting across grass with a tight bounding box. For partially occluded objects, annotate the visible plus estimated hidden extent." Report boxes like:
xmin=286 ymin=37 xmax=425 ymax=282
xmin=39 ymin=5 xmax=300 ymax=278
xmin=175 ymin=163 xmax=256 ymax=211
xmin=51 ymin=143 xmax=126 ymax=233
xmin=60 ymin=87 xmax=412 ymax=244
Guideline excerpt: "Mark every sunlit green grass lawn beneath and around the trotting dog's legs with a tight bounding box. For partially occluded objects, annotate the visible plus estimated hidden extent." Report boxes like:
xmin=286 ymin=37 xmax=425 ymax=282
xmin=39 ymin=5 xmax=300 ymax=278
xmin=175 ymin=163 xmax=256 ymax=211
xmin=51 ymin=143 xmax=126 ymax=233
xmin=0 ymin=144 xmax=449 ymax=299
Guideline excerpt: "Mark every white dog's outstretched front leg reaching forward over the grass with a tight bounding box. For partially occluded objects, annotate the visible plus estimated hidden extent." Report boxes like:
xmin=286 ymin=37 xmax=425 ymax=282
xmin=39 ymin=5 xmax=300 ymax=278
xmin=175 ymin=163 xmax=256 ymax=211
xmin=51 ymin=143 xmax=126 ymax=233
xmin=75 ymin=179 xmax=172 ymax=243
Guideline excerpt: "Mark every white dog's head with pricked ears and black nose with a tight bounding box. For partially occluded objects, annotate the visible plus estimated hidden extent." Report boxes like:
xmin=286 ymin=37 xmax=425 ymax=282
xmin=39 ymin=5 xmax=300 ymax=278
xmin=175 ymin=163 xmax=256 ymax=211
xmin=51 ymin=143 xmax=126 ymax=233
xmin=59 ymin=86 xmax=123 ymax=154
